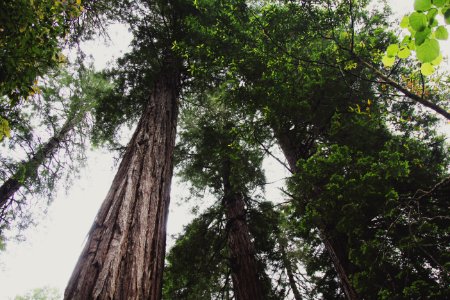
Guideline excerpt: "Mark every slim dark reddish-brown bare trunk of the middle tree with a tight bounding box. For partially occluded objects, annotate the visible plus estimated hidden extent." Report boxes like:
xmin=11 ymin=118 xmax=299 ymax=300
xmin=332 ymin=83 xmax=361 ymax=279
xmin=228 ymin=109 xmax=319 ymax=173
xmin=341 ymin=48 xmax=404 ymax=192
xmin=223 ymin=160 xmax=265 ymax=300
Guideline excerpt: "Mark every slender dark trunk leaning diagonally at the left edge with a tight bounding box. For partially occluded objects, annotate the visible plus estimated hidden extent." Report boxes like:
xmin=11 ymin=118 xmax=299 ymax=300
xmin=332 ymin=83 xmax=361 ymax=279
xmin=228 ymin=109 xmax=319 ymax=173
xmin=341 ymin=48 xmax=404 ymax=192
xmin=0 ymin=113 xmax=79 ymax=211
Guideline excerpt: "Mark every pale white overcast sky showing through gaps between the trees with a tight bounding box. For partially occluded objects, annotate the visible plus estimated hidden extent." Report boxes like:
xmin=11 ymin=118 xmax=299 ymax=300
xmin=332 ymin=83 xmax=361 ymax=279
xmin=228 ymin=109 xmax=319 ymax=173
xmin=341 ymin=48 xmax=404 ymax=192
xmin=0 ymin=0 xmax=449 ymax=300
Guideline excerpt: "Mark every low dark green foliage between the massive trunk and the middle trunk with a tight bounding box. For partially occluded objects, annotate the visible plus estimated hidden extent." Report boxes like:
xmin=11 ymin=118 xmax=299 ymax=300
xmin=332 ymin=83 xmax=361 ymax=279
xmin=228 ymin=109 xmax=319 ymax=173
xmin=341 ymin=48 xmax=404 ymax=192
xmin=163 ymin=207 xmax=232 ymax=300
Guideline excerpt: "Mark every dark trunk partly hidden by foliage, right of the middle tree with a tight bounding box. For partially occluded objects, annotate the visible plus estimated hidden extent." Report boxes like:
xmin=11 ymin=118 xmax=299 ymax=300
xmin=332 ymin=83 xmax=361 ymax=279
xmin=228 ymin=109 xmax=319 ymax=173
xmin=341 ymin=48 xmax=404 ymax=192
xmin=274 ymin=129 xmax=359 ymax=300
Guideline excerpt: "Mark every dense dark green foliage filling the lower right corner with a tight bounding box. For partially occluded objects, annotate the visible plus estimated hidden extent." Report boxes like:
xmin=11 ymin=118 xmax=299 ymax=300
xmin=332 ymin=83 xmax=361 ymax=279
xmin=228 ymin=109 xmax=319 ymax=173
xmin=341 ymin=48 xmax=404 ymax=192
xmin=292 ymin=115 xmax=449 ymax=299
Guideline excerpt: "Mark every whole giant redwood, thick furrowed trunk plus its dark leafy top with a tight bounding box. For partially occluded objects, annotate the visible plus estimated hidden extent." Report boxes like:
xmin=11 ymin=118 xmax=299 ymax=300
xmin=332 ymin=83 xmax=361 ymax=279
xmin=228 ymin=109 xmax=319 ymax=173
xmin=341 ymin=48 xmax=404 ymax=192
xmin=64 ymin=1 xmax=189 ymax=299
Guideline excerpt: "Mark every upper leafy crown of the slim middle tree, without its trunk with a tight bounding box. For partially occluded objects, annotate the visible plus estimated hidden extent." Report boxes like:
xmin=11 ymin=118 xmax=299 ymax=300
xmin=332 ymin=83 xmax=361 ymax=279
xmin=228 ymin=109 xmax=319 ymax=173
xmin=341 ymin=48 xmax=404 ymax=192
xmin=176 ymin=92 xmax=267 ymax=197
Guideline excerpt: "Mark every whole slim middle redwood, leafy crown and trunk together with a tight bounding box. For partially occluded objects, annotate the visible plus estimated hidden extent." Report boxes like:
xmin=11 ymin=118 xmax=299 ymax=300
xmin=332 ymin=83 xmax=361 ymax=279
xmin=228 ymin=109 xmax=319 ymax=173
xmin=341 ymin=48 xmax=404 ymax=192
xmin=174 ymin=96 xmax=270 ymax=300
